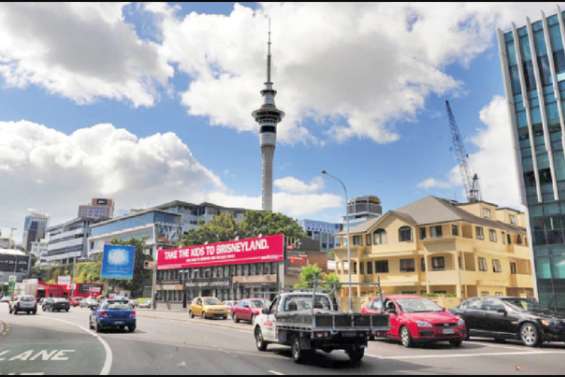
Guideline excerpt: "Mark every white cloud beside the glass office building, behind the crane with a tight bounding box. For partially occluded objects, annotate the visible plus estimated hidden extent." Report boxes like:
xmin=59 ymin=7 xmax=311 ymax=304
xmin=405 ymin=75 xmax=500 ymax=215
xmin=418 ymin=96 xmax=523 ymax=208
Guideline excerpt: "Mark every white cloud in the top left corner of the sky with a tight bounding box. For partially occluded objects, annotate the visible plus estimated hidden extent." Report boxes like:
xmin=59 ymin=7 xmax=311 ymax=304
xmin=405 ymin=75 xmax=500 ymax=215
xmin=0 ymin=3 xmax=174 ymax=106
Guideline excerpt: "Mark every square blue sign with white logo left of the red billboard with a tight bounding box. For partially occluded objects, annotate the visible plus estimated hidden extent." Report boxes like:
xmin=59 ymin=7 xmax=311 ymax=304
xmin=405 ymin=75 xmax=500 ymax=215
xmin=100 ymin=245 xmax=135 ymax=280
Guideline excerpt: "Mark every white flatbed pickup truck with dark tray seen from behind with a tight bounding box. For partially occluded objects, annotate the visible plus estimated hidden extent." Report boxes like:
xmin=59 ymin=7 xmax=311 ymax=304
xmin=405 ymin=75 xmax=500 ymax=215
xmin=253 ymin=292 xmax=389 ymax=364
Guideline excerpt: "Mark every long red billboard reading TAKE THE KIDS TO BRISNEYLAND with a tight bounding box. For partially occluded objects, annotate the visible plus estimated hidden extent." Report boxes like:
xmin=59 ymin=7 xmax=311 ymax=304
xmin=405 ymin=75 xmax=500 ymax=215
xmin=157 ymin=234 xmax=284 ymax=270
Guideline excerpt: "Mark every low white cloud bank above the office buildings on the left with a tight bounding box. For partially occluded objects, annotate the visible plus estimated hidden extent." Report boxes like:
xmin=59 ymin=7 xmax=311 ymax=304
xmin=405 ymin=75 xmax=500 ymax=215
xmin=0 ymin=121 xmax=225 ymax=228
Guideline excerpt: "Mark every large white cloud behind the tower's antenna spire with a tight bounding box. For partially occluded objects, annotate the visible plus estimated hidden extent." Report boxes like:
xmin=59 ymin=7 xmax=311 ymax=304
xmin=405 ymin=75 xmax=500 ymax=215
xmin=151 ymin=3 xmax=564 ymax=143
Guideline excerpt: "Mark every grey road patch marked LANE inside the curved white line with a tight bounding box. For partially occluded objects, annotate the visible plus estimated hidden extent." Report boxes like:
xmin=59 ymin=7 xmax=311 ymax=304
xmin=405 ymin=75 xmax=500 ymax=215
xmin=0 ymin=313 xmax=108 ymax=375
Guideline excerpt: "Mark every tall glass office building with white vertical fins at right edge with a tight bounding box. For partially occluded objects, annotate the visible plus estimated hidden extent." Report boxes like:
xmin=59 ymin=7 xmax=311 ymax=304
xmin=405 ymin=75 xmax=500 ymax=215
xmin=498 ymin=8 xmax=565 ymax=309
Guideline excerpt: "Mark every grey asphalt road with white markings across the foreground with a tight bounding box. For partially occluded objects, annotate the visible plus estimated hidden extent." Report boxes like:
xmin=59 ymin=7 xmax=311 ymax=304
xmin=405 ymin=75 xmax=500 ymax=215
xmin=0 ymin=305 xmax=565 ymax=375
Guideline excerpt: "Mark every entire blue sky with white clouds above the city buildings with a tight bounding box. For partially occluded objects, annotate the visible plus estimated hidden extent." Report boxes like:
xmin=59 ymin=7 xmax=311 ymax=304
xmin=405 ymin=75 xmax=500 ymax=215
xmin=0 ymin=3 xmax=556 ymax=241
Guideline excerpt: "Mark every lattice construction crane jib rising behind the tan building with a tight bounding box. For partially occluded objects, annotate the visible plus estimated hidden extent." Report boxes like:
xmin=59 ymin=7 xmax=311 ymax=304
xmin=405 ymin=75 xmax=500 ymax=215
xmin=445 ymin=100 xmax=481 ymax=202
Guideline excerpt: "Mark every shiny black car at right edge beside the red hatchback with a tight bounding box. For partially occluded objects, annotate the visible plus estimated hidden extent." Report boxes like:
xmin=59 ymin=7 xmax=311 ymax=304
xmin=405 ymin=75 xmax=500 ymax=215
xmin=453 ymin=297 xmax=565 ymax=347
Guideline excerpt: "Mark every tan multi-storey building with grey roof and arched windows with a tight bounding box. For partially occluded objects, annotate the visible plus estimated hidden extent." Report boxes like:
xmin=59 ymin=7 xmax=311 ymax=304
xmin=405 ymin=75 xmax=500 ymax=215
xmin=335 ymin=196 xmax=534 ymax=302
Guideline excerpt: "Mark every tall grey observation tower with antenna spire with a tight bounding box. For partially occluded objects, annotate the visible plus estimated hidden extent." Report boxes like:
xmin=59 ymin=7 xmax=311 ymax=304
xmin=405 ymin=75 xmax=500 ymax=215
xmin=252 ymin=20 xmax=284 ymax=211
